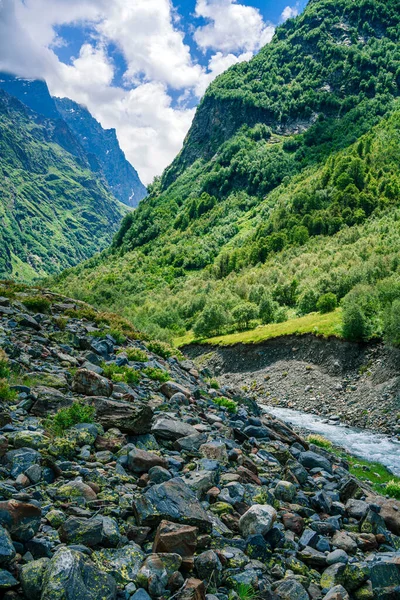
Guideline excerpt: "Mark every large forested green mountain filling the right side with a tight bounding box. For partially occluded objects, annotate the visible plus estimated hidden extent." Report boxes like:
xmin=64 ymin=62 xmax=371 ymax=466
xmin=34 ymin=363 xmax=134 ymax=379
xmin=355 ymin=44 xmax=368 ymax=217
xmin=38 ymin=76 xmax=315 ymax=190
xmin=55 ymin=0 xmax=400 ymax=341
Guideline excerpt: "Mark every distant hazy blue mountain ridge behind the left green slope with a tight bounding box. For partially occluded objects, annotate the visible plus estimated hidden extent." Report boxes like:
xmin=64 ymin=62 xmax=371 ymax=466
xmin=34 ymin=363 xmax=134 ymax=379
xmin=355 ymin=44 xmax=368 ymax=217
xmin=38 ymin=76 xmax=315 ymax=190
xmin=55 ymin=98 xmax=147 ymax=207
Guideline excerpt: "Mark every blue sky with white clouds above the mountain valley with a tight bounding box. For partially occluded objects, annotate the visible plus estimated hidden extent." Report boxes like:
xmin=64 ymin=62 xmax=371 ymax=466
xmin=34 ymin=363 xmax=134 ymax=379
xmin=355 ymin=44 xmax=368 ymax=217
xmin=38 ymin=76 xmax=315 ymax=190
xmin=0 ymin=0 xmax=307 ymax=184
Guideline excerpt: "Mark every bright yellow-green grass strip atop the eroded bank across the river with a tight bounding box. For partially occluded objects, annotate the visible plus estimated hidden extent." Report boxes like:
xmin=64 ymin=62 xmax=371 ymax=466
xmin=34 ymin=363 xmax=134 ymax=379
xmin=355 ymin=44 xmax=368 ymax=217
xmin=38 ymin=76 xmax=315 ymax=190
xmin=175 ymin=308 xmax=342 ymax=347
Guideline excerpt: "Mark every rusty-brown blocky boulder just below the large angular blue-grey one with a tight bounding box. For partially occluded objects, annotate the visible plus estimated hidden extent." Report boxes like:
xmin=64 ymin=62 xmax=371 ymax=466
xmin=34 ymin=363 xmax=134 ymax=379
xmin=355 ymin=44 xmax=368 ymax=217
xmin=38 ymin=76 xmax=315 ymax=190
xmin=153 ymin=521 xmax=198 ymax=569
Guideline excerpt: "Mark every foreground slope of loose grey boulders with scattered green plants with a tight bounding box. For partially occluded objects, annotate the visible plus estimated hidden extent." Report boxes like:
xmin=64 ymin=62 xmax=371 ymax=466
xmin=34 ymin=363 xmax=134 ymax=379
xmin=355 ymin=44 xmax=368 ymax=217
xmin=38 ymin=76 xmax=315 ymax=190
xmin=0 ymin=291 xmax=400 ymax=600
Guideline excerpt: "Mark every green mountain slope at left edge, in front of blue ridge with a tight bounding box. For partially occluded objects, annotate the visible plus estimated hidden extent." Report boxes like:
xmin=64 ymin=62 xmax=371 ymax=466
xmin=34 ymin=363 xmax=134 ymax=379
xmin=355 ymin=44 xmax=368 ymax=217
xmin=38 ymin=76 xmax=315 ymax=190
xmin=0 ymin=90 xmax=126 ymax=279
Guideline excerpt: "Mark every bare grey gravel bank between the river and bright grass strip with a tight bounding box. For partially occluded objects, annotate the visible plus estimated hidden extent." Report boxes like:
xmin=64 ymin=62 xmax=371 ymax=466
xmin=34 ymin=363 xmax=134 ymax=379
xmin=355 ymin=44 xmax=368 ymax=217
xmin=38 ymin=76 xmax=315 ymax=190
xmin=185 ymin=335 xmax=400 ymax=437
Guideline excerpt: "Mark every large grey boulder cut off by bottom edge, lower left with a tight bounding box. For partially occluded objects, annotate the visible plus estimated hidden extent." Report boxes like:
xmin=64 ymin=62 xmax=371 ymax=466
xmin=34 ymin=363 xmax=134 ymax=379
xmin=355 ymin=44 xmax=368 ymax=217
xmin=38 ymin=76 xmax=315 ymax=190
xmin=41 ymin=548 xmax=117 ymax=600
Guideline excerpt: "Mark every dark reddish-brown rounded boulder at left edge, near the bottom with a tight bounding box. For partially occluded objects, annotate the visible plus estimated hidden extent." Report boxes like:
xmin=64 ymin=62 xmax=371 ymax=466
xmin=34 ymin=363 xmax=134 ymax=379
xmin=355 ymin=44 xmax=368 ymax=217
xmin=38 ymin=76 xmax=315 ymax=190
xmin=0 ymin=500 xmax=42 ymax=542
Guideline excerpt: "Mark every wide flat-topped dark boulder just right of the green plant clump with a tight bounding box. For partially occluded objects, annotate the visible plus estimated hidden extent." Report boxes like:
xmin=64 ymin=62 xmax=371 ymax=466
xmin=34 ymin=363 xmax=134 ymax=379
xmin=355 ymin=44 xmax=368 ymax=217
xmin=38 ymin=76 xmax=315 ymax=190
xmin=93 ymin=398 xmax=153 ymax=435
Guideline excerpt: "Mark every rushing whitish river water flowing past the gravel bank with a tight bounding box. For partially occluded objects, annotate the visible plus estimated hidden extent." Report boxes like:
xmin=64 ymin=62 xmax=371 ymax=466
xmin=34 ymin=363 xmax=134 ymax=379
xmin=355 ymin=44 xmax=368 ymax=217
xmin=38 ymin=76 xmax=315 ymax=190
xmin=262 ymin=406 xmax=400 ymax=476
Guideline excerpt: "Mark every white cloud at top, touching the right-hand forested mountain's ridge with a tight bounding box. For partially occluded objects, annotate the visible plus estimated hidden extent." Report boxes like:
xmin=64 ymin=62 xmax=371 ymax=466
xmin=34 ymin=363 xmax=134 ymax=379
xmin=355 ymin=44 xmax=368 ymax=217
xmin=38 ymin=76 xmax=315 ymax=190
xmin=194 ymin=0 xmax=275 ymax=53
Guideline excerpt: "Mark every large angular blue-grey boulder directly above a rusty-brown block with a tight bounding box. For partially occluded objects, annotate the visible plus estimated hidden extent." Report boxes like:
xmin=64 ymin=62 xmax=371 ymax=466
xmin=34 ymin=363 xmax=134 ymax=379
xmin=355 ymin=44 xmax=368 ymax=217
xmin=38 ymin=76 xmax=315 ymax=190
xmin=134 ymin=478 xmax=211 ymax=532
